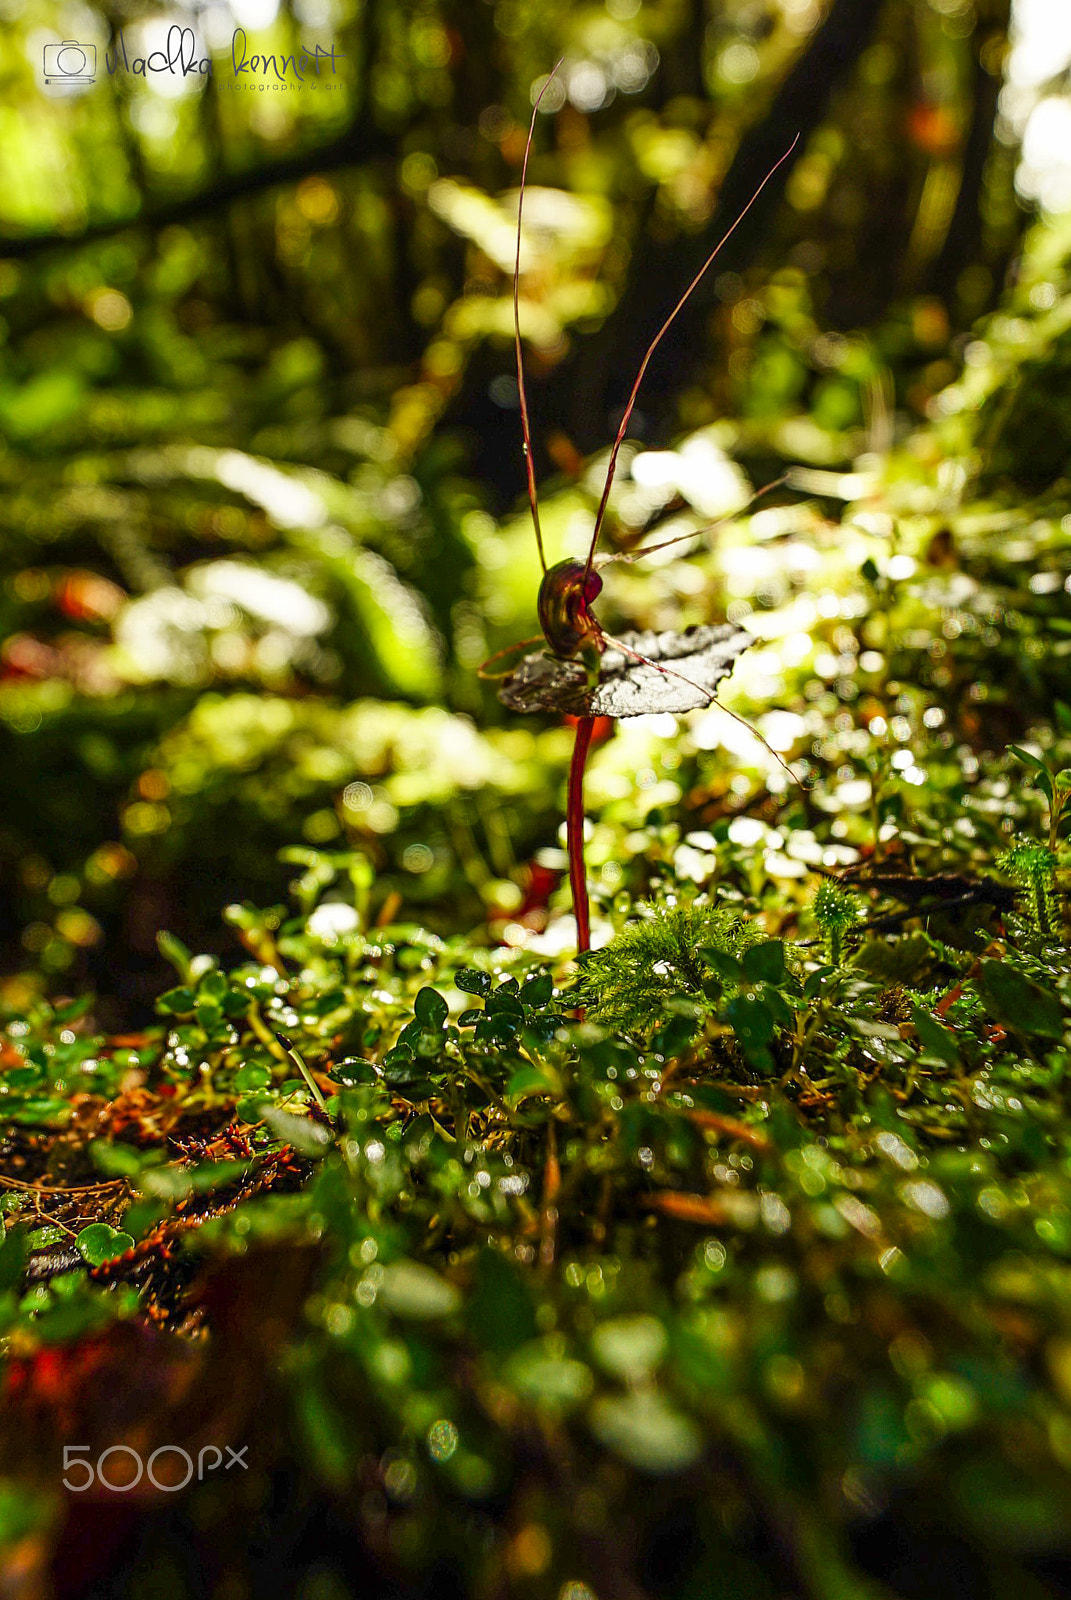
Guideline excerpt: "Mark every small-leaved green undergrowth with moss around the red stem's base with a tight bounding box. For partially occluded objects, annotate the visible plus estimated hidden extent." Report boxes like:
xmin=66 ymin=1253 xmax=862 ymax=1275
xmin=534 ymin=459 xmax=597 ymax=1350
xmin=0 ymin=742 xmax=1071 ymax=1600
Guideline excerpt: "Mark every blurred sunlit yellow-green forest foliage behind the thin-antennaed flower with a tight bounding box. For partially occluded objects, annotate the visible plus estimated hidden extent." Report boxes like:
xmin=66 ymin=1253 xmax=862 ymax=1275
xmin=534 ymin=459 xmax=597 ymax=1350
xmin=0 ymin=0 xmax=1037 ymax=1006
